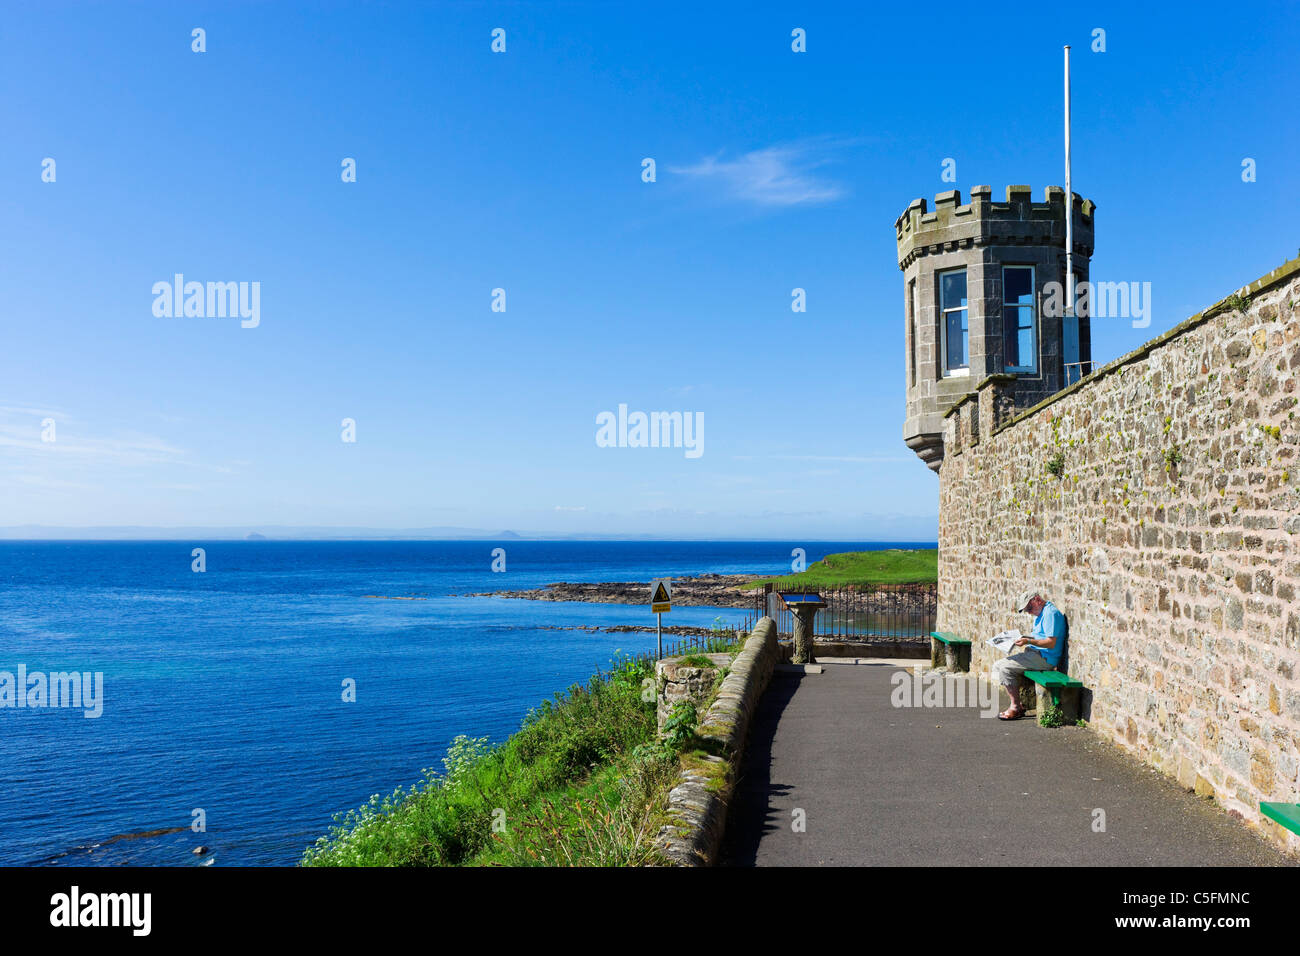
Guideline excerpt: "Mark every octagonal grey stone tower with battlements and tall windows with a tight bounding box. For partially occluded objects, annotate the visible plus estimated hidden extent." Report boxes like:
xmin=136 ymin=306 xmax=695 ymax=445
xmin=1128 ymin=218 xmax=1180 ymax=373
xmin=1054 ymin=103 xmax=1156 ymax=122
xmin=894 ymin=186 xmax=1096 ymax=471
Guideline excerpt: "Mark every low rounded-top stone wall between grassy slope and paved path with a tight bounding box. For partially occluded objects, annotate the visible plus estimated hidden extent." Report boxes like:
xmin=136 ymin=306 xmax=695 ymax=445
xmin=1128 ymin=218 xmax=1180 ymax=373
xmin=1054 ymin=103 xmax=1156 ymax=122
xmin=657 ymin=618 xmax=777 ymax=866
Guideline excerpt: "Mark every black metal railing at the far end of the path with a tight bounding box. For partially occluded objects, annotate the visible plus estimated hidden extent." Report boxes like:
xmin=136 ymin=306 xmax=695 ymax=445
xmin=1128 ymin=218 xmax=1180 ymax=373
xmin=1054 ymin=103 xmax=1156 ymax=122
xmin=754 ymin=584 xmax=939 ymax=641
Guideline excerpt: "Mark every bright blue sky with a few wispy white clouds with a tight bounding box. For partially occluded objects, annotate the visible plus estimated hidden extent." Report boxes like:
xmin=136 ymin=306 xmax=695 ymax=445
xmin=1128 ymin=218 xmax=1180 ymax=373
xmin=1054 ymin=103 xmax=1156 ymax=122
xmin=0 ymin=3 xmax=1300 ymax=540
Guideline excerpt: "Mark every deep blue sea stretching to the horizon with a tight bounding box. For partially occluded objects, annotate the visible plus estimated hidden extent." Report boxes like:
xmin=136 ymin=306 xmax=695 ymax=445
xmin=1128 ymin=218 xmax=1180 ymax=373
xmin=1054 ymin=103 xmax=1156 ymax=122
xmin=0 ymin=540 xmax=933 ymax=866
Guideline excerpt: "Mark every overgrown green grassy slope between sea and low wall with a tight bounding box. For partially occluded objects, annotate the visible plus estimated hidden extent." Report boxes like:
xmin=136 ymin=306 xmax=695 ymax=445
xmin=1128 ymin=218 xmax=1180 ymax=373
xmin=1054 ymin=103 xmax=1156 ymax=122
xmin=302 ymin=634 xmax=743 ymax=866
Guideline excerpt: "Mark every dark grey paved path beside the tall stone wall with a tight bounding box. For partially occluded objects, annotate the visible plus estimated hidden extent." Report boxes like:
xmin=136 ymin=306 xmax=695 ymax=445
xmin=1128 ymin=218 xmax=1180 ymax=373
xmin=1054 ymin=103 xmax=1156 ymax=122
xmin=723 ymin=662 xmax=1295 ymax=866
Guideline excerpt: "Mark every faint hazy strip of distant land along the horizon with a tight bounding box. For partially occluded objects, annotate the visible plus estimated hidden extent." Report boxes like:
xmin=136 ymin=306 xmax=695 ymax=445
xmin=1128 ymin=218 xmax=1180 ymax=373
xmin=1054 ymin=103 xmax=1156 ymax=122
xmin=0 ymin=524 xmax=935 ymax=548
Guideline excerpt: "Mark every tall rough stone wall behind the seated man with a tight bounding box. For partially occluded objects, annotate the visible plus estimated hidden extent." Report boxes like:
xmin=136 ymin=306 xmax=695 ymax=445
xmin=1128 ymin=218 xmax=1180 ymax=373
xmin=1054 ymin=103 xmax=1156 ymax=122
xmin=937 ymin=259 xmax=1300 ymax=852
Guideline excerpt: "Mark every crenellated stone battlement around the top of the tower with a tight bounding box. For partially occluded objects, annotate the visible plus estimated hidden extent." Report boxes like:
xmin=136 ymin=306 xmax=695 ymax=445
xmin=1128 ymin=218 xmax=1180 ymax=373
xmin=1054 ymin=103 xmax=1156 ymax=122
xmin=894 ymin=186 xmax=1097 ymax=269
